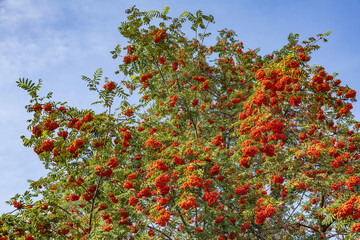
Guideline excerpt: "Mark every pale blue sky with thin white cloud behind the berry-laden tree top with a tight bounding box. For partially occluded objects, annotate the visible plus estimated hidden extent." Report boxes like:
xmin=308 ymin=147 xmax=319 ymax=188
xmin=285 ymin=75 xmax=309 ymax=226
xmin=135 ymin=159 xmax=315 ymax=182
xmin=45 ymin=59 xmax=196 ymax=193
xmin=0 ymin=0 xmax=360 ymax=213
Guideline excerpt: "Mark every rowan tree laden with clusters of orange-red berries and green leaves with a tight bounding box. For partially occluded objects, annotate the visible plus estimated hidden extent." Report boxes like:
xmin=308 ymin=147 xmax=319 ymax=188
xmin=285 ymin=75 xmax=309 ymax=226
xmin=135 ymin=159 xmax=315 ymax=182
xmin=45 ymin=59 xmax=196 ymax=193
xmin=0 ymin=7 xmax=360 ymax=240
